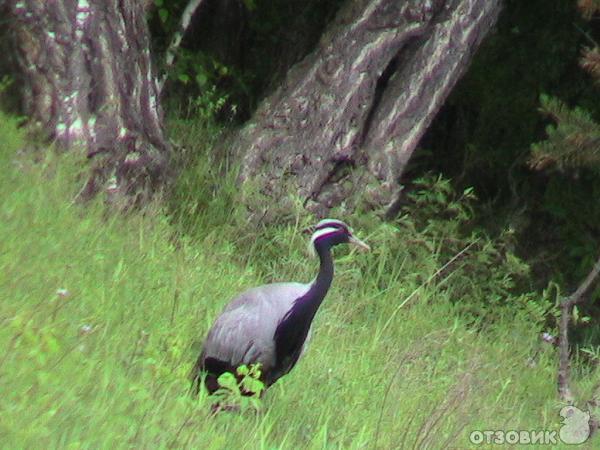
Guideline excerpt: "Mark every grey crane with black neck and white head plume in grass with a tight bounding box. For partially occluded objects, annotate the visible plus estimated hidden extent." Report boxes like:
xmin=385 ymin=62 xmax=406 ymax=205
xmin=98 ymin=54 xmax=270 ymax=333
xmin=192 ymin=219 xmax=370 ymax=394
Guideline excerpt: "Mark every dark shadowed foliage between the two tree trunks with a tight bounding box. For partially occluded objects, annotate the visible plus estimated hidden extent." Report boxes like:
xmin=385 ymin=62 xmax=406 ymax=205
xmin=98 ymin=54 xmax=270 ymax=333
xmin=150 ymin=0 xmax=342 ymax=123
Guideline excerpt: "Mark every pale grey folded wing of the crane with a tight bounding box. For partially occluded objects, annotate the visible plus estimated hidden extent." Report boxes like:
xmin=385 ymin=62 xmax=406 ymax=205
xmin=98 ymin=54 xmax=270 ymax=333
xmin=202 ymin=283 xmax=309 ymax=370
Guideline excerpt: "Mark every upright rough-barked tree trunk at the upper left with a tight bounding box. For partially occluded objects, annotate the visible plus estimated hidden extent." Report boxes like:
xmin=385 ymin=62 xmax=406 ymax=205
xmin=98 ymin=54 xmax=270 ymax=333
xmin=10 ymin=0 xmax=170 ymax=204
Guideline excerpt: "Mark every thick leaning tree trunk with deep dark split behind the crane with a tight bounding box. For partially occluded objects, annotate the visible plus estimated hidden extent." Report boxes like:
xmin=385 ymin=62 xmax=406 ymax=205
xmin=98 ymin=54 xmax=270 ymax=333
xmin=233 ymin=0 xmax=501 ymax=220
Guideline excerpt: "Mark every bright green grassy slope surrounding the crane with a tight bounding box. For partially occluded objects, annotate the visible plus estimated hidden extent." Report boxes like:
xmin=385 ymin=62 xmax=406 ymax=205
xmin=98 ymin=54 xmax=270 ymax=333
xmin=0 ymin=111 xmax=598 ymax=450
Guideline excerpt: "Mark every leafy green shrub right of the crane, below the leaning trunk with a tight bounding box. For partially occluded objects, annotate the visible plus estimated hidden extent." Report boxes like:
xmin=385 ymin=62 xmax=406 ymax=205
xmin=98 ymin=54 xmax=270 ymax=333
xmin=358 ymin=175 xmax=553 ymax=326
